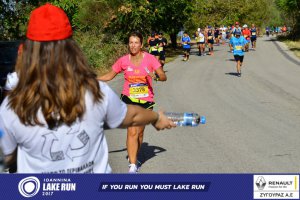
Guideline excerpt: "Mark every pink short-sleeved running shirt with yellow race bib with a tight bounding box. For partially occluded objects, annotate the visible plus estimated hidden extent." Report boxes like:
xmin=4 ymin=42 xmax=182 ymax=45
xmin=112 ymin=52 xmax=161 ymax=102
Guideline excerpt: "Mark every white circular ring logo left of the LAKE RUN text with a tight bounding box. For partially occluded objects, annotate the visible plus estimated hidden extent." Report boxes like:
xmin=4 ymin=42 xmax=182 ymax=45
xmin=18 ymin=176 xmax=40 ymax=197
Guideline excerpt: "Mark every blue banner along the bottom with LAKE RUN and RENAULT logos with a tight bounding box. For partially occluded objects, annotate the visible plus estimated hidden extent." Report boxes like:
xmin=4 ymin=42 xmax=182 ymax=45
xmin=0 ymin=174 xmax=299 ymax=200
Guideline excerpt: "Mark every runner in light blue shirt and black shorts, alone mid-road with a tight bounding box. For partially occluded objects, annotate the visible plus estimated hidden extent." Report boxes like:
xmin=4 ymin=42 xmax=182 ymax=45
xmin=230 ymin=31 xmax=247 ymax=77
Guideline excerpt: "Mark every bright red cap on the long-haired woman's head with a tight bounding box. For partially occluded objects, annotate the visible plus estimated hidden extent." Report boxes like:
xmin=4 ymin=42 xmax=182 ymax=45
xmin=26 ymin=3 xmax=72 ymax=41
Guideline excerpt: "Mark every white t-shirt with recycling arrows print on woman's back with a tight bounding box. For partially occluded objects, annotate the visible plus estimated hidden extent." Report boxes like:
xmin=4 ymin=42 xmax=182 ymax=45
xmin=0 ymin=82 xmax=127 ymax=173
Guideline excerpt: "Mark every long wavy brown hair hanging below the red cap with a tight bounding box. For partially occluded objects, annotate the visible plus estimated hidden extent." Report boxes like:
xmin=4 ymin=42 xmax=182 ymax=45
xmin=8 ymin=38 xmax=102 ymax=128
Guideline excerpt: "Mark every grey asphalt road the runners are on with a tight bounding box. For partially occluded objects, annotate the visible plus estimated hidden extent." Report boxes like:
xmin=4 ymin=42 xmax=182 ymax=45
xmin=106 ymin=38 xmax=300 ymax=173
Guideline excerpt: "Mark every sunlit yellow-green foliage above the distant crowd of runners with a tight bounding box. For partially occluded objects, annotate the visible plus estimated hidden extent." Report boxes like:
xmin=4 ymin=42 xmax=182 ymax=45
xmin=186 ymin=0 xmax=280 ymax=30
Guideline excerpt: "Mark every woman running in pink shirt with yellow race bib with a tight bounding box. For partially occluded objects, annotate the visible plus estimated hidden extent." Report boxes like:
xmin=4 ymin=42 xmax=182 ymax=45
xmin=99 ymin=32 xmax=167 ymax=173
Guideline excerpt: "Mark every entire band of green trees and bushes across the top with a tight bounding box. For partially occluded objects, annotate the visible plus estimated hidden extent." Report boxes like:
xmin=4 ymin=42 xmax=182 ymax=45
xmin=0 ymin=0 xmax=300 ymax=66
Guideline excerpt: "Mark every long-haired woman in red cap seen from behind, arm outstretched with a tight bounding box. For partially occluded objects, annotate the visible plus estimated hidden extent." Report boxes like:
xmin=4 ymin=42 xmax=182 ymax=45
xmin=0 ymin=4 xmax=174 ymax=173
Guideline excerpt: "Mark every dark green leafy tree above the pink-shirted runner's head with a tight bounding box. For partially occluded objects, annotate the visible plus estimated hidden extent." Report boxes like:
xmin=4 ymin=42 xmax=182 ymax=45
xmin=107 ymin=0 xmax=192 ymax=44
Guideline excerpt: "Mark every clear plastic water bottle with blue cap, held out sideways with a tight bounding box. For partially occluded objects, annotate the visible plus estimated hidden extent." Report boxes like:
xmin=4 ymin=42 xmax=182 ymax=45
xmin=164 ymin=112 xmax=206 ymax=127
